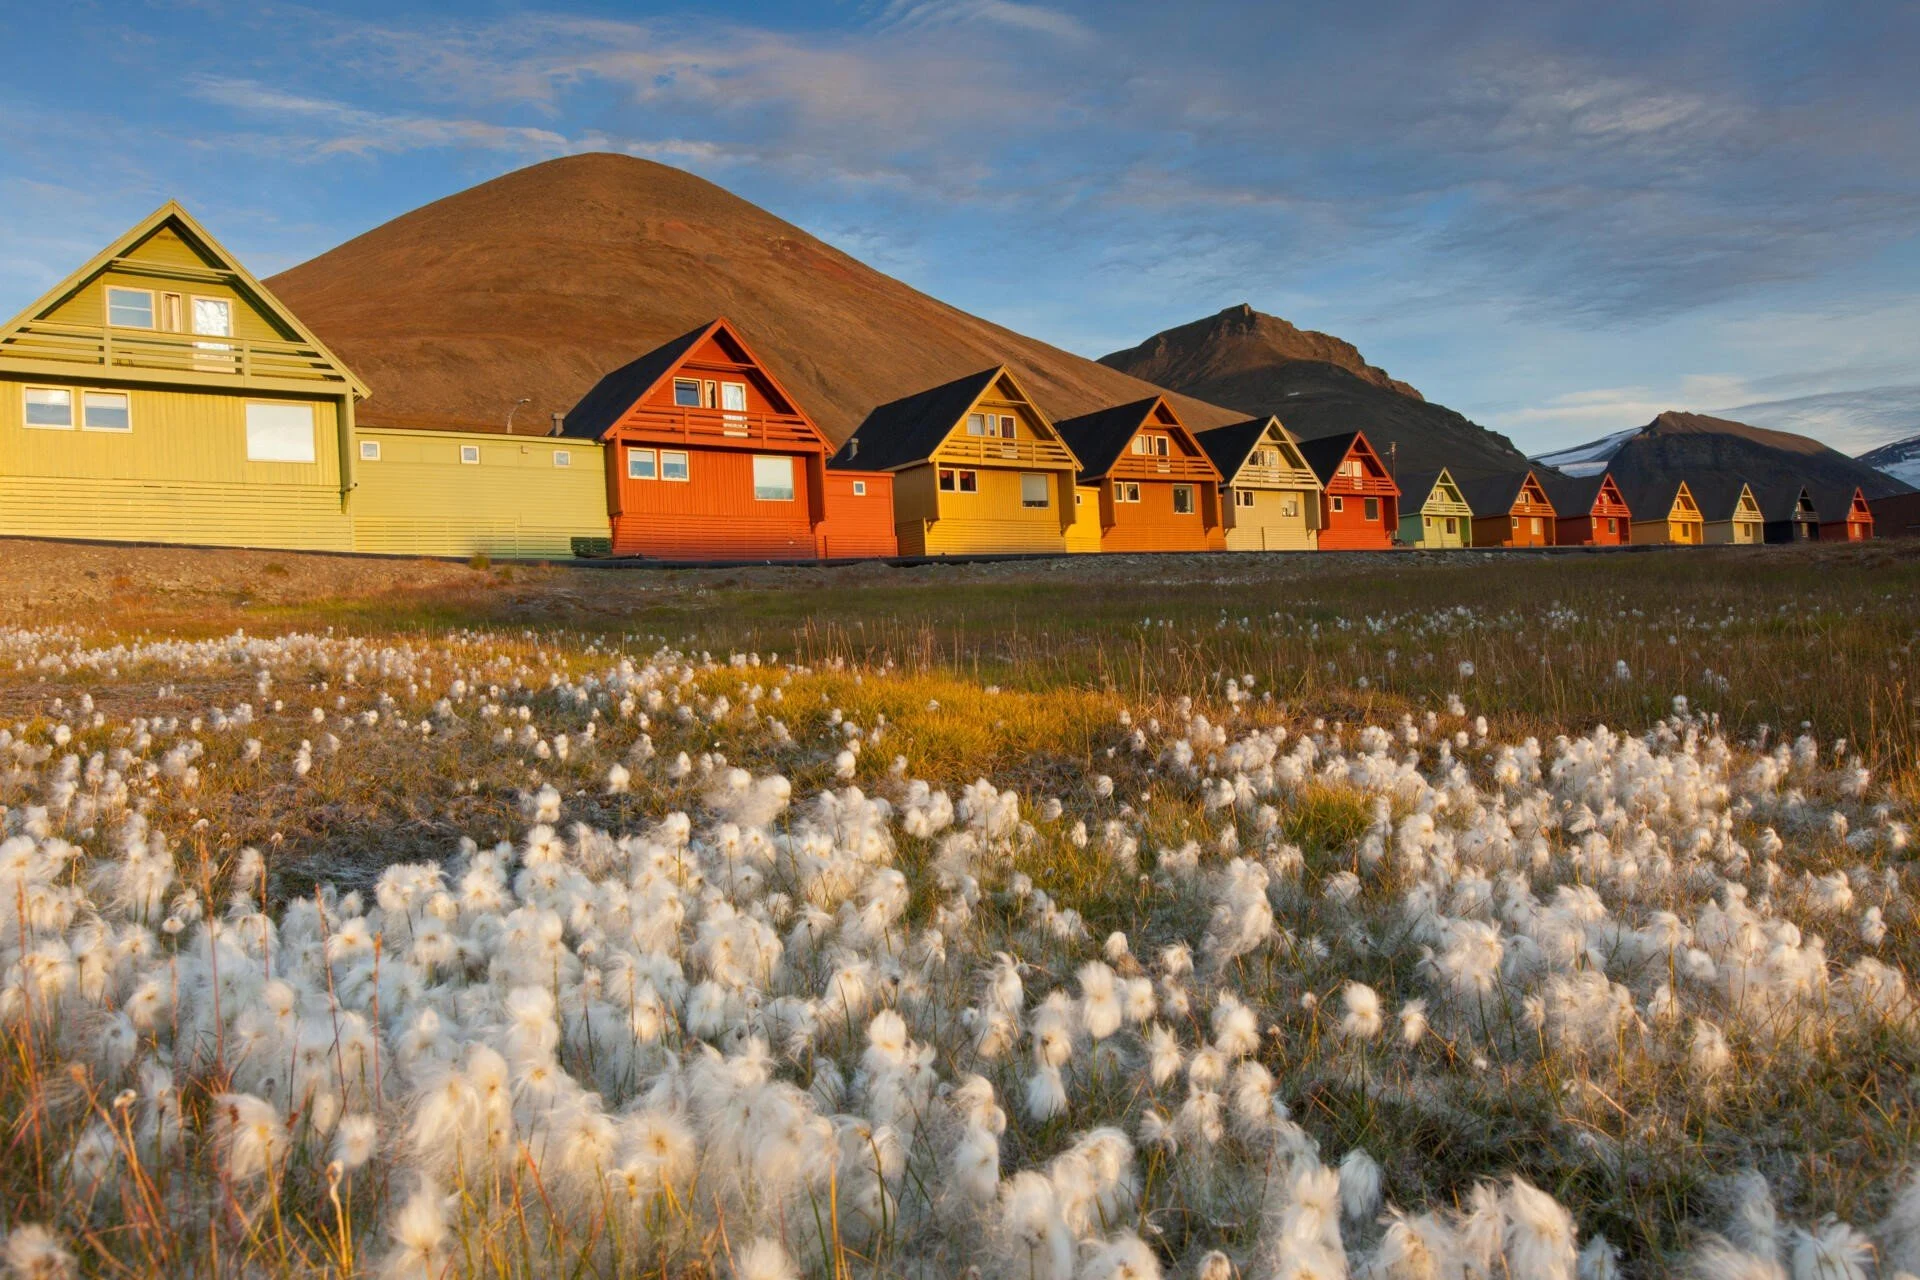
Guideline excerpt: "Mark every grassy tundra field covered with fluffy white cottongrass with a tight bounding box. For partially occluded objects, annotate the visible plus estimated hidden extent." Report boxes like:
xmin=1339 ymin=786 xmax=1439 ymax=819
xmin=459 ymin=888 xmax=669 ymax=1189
xmin=0 ymin=543 xmax=1920 ymax=1280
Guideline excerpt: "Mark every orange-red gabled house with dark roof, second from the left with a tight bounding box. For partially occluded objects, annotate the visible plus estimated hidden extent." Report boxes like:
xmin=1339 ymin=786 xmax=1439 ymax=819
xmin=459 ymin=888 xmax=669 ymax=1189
xmin=561 ymin=319 xmax=825 ymax=560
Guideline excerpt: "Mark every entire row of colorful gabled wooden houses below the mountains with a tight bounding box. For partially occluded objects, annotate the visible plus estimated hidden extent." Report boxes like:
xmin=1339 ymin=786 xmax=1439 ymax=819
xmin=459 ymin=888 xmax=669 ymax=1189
xmin=0 ymin=203 xmax=1872 ymax=560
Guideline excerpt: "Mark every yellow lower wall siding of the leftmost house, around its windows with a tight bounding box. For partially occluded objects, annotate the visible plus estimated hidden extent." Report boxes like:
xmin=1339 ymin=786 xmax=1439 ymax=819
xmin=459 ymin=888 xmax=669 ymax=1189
xmin=0 ymin=376 xmax=353 ymax=551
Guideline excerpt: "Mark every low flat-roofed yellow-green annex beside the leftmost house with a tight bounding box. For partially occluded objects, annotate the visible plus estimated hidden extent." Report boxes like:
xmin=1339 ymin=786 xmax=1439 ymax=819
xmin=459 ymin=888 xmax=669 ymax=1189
xmin=348 ymin=426 xmax=611 ymax=558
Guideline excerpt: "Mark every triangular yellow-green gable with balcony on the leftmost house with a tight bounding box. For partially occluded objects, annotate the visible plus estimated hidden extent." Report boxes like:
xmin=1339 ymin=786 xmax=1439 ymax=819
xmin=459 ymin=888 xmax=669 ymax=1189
xmin=0 ymin=201 xmax=367 ymax=399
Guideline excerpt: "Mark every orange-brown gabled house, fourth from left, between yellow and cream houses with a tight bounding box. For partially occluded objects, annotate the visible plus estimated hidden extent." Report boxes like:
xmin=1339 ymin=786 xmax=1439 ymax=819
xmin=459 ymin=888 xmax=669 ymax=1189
xmin=1054 ymin=395 xmax=1227 ymax=551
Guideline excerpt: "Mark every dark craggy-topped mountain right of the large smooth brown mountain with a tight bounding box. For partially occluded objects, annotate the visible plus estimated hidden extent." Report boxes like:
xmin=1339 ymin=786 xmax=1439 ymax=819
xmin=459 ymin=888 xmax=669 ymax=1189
xmin=1100 ymin=305 xmax=1526 ymax=480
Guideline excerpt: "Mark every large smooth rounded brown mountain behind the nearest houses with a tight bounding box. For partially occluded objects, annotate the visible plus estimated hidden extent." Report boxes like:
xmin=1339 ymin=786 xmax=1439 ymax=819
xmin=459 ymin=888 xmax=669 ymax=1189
xmin=267 ymin=155 xmax=1242 ymax=441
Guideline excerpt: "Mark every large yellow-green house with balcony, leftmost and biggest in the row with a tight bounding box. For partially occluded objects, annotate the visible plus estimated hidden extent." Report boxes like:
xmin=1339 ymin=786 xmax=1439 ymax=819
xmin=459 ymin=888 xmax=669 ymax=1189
xmin=0 ymin=203 xmax=367 ymax=551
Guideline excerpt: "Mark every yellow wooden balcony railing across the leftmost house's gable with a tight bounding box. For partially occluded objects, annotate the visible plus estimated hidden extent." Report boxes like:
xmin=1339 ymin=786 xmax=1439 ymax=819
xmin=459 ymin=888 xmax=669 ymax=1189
xmin=0 ymin=320 xmax=346 ymax=384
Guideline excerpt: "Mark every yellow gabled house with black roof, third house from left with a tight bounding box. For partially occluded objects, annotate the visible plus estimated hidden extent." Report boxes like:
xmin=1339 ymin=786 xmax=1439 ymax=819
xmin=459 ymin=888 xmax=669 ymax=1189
xmin=831 ymin=365 xmax=1079 ymax=557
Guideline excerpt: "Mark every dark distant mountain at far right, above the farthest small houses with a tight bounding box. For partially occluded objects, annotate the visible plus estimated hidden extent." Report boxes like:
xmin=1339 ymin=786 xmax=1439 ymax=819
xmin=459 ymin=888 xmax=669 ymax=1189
xmin=1536 ymin=411 xmax=1907 ymax=497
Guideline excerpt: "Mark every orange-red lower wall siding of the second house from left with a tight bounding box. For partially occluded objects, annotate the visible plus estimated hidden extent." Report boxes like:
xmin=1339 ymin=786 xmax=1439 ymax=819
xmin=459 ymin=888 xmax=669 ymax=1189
xmin=607 ymin=445 xmax=822 ymax=560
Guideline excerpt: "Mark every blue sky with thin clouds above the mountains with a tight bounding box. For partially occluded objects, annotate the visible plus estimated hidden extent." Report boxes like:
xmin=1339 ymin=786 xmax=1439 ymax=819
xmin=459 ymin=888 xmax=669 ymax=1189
xmin=0 ymin=0 xmax=1920 ymax=453
